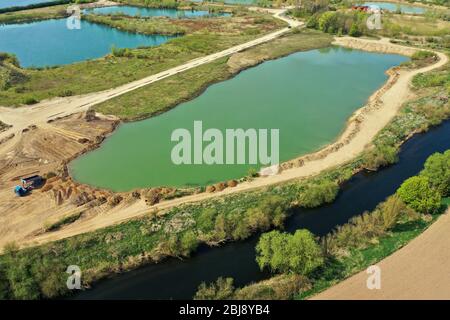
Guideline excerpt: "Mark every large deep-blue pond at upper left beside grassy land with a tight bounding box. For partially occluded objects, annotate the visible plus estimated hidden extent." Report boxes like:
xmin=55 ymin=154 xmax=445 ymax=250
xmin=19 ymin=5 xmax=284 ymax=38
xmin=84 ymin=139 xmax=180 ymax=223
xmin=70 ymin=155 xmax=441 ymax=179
xmin=0 ymin=18 xmax=171 ymax=67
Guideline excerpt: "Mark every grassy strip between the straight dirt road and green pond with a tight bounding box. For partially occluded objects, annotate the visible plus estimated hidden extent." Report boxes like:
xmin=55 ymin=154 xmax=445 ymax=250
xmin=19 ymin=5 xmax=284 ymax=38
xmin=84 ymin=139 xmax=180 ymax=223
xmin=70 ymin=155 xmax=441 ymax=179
xmin=95 ymin=31 xmax=331 ymax=120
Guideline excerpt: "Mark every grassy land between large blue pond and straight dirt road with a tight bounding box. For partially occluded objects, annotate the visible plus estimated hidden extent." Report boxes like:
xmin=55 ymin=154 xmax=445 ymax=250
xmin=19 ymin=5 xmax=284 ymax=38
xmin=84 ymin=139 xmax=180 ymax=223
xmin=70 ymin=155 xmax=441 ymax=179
xmin=0 ymin=10 xmax=285 ymax=106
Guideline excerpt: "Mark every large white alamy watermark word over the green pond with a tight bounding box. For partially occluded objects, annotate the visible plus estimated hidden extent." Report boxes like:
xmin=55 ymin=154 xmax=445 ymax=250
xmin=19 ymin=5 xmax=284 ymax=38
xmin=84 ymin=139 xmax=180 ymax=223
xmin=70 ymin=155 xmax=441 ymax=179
xmin=171 ymin=121 xmax=280 ymax=172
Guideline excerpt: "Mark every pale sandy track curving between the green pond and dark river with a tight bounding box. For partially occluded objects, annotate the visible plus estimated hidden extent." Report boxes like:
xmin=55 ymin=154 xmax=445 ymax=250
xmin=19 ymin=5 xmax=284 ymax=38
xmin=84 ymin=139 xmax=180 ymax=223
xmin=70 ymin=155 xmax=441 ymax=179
xmin=14 ymin=37 xmax=448 ymax=245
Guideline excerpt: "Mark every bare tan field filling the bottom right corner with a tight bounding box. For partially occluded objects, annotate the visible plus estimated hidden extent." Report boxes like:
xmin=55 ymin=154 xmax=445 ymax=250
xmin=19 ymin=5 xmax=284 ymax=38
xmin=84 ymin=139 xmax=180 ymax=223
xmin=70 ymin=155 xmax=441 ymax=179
xmin=313 ymin=210 xmax=450 ymax=300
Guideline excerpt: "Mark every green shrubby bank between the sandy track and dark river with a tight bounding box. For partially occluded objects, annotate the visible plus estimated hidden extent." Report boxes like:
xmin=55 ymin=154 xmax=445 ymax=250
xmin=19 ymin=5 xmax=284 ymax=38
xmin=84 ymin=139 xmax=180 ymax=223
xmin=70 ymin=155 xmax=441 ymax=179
xmin=0 ymin=48 xmax=450 ymax=299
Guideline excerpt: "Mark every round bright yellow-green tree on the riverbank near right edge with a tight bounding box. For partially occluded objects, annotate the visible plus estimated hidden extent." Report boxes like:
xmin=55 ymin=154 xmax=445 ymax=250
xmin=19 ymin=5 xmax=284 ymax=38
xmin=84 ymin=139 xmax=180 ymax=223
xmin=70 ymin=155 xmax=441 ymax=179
xmin=397 ymin=176 xmax=441 ymax=213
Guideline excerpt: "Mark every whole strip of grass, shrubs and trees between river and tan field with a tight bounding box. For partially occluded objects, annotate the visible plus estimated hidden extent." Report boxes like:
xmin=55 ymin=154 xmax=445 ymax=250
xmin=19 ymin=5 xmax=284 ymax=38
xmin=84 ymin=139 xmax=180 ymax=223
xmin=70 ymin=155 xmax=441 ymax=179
xmin=195 ymin=150 xmax=450 ymax=299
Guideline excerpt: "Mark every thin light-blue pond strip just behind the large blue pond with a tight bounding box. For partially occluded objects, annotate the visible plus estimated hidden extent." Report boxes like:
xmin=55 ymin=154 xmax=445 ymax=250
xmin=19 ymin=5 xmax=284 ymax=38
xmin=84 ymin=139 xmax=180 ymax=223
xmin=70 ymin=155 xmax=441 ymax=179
xmin=84 ymin=6 xmax=230 ymax=18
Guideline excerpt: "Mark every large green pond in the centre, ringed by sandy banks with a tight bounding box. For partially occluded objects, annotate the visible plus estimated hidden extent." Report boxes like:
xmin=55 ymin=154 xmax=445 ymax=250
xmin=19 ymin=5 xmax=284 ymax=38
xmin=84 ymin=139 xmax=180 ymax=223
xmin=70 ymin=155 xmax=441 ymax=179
xmin=70 ymin=47 xmax=407 ymax=191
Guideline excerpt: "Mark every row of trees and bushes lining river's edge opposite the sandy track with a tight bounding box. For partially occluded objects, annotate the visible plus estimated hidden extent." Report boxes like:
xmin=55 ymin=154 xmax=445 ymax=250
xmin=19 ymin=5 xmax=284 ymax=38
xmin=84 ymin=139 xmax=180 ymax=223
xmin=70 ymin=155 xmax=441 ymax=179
xmin=256 ymin=150 xmax=450 ymax=275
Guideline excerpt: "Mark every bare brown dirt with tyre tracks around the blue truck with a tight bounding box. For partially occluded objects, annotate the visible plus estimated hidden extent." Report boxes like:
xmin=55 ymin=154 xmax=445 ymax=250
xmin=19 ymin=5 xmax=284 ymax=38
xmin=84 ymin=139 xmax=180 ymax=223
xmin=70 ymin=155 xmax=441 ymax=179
xmin=0 ymin=114 xmax=117 ymax=246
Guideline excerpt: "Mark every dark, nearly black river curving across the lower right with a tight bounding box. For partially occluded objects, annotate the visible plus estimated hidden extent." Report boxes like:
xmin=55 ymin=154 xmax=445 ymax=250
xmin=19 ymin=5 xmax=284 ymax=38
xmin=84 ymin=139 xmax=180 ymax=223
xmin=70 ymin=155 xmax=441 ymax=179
xmin=75 ymin=121 xmax=450 ymax=299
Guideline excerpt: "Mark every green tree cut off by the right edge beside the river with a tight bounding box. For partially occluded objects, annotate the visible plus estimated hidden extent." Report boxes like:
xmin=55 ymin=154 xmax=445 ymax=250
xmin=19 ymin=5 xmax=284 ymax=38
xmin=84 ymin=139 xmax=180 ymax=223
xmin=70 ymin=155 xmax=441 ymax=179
xmin=420 ymin=150 xmax=450 ymax=197
